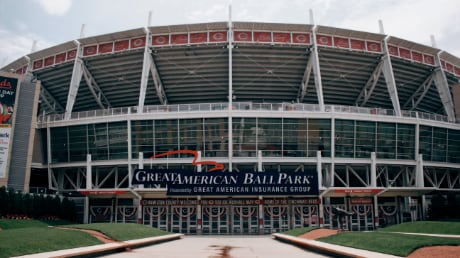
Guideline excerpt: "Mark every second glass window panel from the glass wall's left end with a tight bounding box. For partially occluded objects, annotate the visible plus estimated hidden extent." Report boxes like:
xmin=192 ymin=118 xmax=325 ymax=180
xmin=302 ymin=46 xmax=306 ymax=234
xmin=69 ymin=125 xmax=88 ymax=161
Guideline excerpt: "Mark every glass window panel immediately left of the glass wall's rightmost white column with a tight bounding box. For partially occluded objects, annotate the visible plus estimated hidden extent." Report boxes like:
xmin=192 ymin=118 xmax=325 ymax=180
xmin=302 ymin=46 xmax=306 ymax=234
xmin=396 ymin=124 xmax=415 ymax=159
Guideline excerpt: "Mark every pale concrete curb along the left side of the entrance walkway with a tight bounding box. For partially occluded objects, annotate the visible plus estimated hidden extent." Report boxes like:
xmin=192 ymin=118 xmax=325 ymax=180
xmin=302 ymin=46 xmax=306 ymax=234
xmin=16 ymin=234 xmax=184 ymax=258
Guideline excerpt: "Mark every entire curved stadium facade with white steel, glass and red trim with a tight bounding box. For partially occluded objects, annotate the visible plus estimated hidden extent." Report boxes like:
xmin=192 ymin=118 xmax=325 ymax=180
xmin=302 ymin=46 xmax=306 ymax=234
xmin=0 ymin=22 xmax=460 ymax=234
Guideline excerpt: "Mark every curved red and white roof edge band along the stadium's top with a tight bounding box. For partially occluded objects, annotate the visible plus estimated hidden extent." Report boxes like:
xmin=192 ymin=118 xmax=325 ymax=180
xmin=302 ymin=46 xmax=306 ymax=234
xmin=0 ymin=21 xmax=460 ymax=71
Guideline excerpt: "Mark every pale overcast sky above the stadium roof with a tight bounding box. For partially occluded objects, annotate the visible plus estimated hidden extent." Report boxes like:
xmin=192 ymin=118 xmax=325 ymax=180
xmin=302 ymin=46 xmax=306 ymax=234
xmin=0 ymin=0 xmax=460 ymax=67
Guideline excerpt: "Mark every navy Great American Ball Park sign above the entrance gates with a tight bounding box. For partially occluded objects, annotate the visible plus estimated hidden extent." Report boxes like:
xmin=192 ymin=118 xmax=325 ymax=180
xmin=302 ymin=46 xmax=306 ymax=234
xmin=132 ymin=169 xmax=318 ymax=195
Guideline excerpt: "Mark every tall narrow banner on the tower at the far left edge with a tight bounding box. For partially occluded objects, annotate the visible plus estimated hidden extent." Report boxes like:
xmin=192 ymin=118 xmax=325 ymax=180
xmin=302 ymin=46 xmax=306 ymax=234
xmin=0 ymin=76 xmax=18 ymax=178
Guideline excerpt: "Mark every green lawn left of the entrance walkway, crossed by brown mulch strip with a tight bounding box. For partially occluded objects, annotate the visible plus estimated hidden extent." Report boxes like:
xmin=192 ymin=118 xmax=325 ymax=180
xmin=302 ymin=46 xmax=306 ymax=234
xmin=0 ymin=219 xmax=169 ymax=258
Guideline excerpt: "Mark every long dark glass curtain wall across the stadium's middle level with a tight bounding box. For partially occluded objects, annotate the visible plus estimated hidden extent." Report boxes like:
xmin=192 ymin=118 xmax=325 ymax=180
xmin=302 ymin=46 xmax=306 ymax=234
xmin=50 ymin=117 xmax=460 ymax=163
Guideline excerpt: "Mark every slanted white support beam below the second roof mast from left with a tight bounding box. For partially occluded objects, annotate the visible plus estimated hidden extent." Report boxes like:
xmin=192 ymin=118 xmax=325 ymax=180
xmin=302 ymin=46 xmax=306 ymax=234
xmin=64 ymin=40 xmax=83 ymax=120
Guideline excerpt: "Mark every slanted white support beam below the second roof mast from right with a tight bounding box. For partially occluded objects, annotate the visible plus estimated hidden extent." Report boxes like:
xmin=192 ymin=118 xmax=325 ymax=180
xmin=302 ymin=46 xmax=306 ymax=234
xmin=382 ymin=37 xmax=402 ymax=116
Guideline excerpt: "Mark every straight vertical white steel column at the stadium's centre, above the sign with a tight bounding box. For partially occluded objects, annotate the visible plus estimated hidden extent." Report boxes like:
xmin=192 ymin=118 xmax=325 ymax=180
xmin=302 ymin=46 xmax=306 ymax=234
xmin=227 ymin=5 xmax=233 ymax=171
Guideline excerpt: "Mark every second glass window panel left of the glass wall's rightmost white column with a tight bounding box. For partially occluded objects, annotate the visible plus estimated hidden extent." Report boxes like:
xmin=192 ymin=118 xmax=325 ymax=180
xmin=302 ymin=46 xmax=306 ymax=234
xmin=377 ymin=123 xmax=396 ymax=159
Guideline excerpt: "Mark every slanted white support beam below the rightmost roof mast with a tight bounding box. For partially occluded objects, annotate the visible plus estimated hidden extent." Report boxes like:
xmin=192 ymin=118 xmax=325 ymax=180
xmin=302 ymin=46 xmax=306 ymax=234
xmin=434 ymin=51 xmax=455 ymax=122
